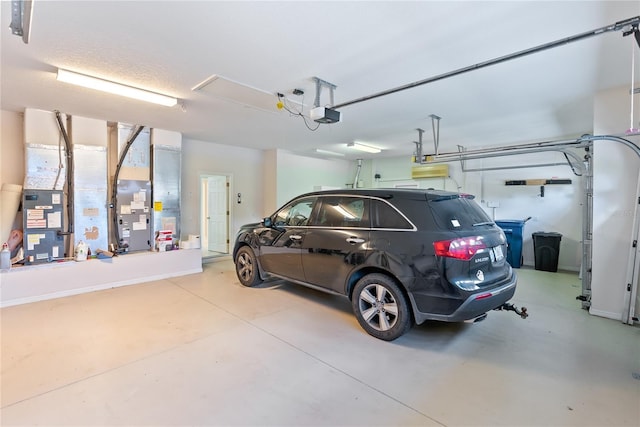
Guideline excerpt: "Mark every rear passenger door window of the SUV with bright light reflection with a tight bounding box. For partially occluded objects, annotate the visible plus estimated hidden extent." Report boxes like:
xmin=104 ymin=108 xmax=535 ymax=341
xmin=313 ymin=196 xmax=369 ymax=228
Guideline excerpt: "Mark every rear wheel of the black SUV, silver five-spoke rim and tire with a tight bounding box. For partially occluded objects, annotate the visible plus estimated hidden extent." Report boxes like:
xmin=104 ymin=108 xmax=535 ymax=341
xmin=351 ymin=273 xmax=412 ymax=341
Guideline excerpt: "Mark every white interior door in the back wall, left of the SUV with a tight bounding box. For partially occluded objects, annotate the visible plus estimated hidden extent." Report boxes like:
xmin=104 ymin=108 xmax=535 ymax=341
xmin=206 ymin=176 xmax=229 ymax=254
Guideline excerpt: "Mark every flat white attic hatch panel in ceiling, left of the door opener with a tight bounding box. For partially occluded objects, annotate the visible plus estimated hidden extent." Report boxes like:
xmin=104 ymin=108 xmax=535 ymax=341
xmin=191 ymin=74 xmax=294 ymax=113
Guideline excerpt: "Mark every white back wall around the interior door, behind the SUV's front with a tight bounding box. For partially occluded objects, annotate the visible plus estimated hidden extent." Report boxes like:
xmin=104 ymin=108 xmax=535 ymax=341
xmin=175 ymin=145 xmax=355 ymax=241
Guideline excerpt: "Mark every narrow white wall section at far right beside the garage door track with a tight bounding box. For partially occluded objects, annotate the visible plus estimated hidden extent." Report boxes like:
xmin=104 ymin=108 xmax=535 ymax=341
xmin=590 ymin=87 xmax=640 ymax=320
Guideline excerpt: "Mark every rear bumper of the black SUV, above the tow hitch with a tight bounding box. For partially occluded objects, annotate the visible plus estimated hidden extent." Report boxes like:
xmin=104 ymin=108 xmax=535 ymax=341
xmin=412 ymin=272 xmax=517 ymax=324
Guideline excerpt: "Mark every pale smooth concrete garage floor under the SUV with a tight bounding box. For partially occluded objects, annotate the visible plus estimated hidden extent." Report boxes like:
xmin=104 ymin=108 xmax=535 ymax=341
xmin=0 ymin=259 xmax=640 ymax=426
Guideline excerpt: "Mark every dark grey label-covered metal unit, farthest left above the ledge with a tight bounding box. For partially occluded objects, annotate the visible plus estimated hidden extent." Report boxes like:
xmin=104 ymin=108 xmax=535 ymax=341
xmin=22 ymin=189 xmax=65 ymax=264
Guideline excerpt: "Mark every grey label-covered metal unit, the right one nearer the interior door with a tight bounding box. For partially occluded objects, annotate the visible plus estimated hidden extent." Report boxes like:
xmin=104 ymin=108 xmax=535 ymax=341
xmin=116 ymin=179 xmax=153 ymax=252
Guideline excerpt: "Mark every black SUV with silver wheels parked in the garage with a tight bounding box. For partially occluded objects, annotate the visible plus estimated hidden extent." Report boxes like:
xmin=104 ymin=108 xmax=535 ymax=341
xmin=233 ymin=189 xmax=516 ymax=340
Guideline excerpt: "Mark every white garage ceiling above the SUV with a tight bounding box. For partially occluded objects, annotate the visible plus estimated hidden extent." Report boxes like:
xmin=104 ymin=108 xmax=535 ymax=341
xmin=0 ymin=0 xmax=640 ymax=158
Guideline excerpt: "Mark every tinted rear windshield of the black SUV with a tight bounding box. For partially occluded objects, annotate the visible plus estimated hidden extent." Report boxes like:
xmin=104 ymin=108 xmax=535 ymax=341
xmin=429 ymin=197 xmax=493 ymax=230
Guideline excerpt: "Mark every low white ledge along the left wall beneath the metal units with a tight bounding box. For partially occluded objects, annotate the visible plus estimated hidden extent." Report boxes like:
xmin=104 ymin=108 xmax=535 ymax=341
xmin=0 ymin=249 xmax=202 ymax=307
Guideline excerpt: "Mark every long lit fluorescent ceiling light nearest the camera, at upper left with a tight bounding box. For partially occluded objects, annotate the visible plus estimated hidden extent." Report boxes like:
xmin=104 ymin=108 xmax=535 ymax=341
xmin=57 ymin=68 xmax=178 ymax=107
